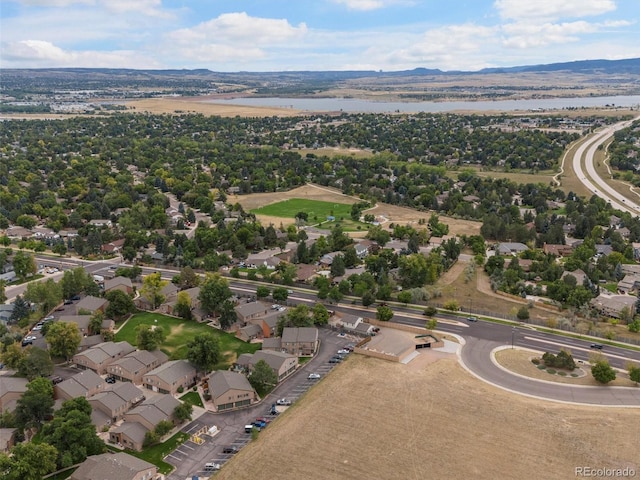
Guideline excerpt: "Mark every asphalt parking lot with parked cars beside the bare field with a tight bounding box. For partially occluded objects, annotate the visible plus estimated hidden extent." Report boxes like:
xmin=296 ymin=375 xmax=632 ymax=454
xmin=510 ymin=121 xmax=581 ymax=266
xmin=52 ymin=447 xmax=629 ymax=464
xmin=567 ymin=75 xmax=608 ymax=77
xmin=164 ymin=329 xmax=358 ymax=480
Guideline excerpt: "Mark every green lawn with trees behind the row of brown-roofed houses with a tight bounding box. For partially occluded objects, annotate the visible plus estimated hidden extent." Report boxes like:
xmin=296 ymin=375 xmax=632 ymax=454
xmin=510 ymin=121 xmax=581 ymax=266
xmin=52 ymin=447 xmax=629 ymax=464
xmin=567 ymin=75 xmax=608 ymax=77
xmin=115 ymin=312 xmax=260 ymax=370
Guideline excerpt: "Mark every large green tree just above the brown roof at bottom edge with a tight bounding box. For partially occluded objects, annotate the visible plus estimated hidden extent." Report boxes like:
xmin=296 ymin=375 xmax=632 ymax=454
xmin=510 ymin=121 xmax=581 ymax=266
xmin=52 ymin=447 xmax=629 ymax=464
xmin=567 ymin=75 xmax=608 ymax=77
xmin=42 ymin=397 xmax=106 ymax=468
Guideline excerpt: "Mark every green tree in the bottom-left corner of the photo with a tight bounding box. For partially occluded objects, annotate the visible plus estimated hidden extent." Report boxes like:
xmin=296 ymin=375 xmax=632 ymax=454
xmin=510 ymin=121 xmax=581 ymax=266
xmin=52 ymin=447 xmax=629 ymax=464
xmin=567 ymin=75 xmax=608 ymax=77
xmin=0 ymin=442 xmax=58 ymax=480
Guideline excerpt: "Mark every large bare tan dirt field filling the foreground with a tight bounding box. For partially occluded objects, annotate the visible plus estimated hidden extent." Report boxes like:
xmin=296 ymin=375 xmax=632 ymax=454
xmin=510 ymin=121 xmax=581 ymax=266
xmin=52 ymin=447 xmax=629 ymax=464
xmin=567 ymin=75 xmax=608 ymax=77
xmin=216 ymin=353 xmax=640 ymax=480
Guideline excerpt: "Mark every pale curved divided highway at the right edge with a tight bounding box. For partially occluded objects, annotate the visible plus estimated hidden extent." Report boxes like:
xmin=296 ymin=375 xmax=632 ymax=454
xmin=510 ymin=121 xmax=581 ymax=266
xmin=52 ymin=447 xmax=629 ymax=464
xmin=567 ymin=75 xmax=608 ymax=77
xmin=573 ymin=117 xmax=640 ymax=215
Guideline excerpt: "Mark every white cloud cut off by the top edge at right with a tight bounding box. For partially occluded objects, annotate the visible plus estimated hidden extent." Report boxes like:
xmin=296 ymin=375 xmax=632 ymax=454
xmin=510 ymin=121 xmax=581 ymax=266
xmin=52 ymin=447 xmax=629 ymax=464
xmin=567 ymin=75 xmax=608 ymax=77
xmin=494 ymin=0 xmax=616 ymax=20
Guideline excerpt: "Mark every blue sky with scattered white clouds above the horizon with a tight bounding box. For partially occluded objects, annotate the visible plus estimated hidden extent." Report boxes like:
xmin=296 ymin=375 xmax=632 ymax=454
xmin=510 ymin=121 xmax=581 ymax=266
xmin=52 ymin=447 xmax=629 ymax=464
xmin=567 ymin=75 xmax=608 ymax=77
xmin=0 ymin=0 xmax=640 ymax=72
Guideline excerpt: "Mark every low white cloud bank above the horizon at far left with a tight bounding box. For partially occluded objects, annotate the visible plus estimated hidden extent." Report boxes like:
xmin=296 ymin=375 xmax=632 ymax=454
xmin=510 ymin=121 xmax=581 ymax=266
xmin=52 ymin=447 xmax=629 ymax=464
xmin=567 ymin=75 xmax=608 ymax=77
xmin=0 ymin=40 xmax=162 ymax=68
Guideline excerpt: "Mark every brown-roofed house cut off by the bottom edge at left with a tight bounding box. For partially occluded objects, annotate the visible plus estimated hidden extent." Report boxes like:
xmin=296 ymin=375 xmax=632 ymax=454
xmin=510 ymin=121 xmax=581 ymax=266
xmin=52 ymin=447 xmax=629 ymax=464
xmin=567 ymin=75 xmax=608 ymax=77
xmin=69 ymin=452 xmax=158 ymax=480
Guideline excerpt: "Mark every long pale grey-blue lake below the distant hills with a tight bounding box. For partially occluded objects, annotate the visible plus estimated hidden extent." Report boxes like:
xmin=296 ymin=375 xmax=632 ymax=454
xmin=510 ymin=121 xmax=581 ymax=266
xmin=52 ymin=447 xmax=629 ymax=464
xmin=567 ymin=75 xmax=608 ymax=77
xmin=206 ymin=95 xmax=640 ymax=113
